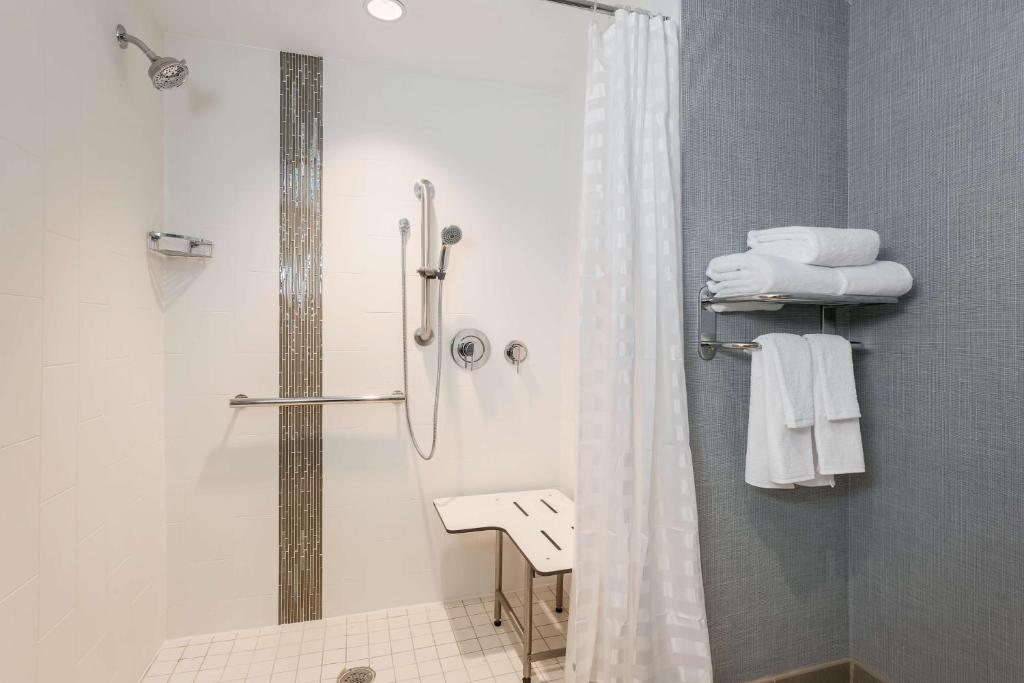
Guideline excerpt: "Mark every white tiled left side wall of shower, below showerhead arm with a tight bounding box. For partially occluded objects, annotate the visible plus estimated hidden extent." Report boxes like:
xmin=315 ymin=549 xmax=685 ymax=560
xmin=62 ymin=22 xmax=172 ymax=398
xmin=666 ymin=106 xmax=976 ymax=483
xmin=0 ymin=0 xmax=165 ymax=683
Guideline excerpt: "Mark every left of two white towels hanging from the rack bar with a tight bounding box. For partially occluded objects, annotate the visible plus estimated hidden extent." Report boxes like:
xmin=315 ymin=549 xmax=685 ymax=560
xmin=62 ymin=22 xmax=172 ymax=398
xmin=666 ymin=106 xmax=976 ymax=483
xmin=745 ymin=334 xmax=816 ymax=488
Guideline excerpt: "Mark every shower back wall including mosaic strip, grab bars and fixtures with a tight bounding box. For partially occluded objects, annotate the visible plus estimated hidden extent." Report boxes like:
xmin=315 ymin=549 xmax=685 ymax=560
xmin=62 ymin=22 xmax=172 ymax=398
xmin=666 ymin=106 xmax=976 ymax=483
xmin=156 ymin=3 xmax=589 ymax=647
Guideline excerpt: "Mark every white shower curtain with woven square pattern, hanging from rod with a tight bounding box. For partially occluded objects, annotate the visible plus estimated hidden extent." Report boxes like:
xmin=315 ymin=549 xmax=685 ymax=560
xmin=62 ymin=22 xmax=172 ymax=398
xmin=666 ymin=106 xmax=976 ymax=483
xmin=565 ymin=11 xmax=712 ymax=683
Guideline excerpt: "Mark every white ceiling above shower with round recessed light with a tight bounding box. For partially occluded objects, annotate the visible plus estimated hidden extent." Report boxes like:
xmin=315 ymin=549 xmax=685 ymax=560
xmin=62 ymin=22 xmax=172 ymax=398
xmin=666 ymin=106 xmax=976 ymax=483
xmin=145 ymin=0 xmax=606 ymax=88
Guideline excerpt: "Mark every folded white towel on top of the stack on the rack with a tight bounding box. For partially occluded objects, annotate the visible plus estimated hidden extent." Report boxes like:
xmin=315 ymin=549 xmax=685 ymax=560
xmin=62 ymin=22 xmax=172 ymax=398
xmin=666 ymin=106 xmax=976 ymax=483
xmin=746 ymin=225 xmax=880 ymax=266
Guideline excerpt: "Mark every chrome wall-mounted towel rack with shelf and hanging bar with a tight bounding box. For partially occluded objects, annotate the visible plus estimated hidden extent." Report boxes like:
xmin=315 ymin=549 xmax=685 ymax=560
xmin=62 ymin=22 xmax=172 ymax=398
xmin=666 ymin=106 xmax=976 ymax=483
xmin=697 ymin=287 xmax=899 ymax=360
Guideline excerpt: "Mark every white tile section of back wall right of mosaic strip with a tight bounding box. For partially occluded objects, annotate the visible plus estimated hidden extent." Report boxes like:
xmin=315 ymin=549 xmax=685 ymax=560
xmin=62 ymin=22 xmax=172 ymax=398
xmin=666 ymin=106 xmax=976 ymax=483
xmin=324 ymin=60 xmax=577 ymax=615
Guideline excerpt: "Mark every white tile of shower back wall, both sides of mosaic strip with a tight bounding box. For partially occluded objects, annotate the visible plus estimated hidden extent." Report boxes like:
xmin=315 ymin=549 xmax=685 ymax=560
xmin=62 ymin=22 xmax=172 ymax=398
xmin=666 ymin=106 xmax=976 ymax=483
xmin=165 ymin=35 xmax=579 ymax=636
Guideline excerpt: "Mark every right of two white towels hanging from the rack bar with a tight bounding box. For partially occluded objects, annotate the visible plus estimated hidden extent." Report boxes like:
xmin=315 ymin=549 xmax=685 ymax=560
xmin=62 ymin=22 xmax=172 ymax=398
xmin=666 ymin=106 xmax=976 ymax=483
xmin=805 ymin=335 xmax=864 ymax=474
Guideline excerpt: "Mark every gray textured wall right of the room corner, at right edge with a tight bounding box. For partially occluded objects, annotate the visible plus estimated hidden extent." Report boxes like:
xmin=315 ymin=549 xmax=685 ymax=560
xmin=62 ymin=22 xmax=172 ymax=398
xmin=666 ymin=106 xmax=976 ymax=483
xmin=849 ymin=0 xmax=1024 ymax=683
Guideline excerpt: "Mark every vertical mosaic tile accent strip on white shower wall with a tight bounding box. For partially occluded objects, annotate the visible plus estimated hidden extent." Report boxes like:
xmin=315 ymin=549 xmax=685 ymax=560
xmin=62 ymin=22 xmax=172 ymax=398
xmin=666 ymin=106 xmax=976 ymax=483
xmin=278 ymin=52 xmax=324 ymax=624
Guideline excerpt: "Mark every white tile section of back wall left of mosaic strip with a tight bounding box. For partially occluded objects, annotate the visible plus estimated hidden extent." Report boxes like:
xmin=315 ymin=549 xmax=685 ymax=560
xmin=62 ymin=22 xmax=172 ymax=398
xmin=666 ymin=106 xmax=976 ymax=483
xmin=162 ymin=35 xmax=280 ymax=635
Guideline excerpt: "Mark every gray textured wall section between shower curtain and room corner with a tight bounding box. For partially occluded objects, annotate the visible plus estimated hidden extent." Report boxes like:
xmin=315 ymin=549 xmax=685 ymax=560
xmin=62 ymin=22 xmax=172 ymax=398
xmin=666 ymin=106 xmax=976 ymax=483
xmin=682 ymin=0 xmax=848 ymax=683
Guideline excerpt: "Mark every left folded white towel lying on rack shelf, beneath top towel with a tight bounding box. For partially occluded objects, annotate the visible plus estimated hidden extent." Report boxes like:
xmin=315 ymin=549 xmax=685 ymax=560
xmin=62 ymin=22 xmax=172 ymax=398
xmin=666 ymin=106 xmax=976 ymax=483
xmin=707 ymin=252 xmax=843 ymax=297
